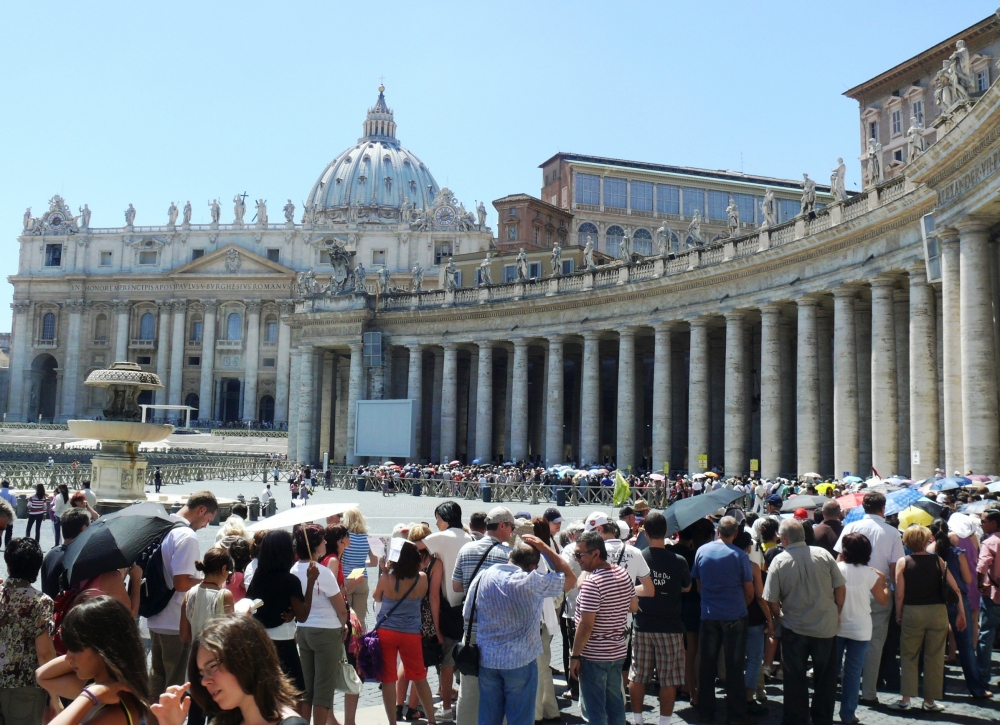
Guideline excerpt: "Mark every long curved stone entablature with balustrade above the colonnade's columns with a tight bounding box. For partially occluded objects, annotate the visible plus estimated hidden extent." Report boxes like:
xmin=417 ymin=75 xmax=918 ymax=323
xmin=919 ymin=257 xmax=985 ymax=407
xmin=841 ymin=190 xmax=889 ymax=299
xmin=290 ymin=178 xmax=934 ymax=345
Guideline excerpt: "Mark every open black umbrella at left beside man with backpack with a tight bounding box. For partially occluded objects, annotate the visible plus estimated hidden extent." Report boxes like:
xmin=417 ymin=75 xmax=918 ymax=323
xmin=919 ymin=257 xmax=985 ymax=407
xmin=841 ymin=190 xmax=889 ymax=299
xmin=63 ymin=501 xmax=174 ymax=586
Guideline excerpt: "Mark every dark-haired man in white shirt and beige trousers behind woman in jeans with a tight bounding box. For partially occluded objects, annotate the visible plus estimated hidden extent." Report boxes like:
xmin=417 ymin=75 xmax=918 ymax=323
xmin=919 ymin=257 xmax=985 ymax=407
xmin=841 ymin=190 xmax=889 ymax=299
xmin=833 ymin=491 xmax=904 ymax=706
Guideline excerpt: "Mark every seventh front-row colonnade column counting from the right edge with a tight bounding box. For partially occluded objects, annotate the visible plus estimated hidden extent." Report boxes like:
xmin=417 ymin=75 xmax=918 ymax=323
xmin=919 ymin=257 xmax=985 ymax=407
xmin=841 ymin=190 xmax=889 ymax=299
xmin=760 ymin=305 xmax=782 ymax=478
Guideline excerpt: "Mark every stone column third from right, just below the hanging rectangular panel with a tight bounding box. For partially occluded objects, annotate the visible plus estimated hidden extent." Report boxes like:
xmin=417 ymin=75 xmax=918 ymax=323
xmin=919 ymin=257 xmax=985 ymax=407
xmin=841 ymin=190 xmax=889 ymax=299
xmin=909 ymin=264 xmax=940 ymax=481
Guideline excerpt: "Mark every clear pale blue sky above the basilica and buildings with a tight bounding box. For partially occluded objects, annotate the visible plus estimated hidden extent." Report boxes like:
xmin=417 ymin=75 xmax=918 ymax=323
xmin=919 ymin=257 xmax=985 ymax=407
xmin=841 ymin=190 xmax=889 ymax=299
xmin=0 ymin=0 xmax=996 ymax=330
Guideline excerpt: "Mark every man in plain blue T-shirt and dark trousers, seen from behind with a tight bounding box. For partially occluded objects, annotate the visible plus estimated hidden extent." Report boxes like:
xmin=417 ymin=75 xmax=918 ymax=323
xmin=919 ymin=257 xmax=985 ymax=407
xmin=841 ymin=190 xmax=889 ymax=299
xmin=691 ymin=516 xmax=754 ymax=725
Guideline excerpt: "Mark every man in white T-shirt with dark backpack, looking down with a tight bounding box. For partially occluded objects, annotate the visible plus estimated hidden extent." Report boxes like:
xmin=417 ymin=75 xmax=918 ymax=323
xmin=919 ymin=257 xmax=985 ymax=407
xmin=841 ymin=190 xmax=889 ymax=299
xmin=147 ymin=491 xmax=219 ymax=725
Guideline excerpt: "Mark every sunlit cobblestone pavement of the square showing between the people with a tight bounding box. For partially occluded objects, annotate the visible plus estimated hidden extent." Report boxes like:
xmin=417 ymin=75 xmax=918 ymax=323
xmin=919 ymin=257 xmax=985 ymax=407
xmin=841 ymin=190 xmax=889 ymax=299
xmin=0 ymin=481 xmax=1000 ymax=725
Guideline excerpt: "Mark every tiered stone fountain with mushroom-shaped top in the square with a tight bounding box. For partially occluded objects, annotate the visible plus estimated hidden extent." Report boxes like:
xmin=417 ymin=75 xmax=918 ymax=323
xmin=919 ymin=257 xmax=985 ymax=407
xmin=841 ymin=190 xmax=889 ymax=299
xmin=68 ymin=362 xmax=174 ymax=509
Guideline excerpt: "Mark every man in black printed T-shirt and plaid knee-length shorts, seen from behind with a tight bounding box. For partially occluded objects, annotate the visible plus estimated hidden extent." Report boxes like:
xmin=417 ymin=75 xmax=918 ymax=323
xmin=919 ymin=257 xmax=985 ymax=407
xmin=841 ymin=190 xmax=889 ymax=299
xmin=628 ymin=511 xmax=692 ymax=725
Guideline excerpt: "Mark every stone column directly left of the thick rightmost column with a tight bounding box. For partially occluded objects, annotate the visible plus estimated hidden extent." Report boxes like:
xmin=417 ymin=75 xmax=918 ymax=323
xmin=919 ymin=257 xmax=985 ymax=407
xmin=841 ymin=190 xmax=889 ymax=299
xmin=937 ymin=229 xmax=967 ymax=475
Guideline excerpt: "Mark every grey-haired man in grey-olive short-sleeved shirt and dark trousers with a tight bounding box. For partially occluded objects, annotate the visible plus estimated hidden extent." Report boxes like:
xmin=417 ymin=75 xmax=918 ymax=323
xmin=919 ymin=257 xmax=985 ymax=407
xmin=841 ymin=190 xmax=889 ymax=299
xmin=764 ymin=519 xmax=847 ymax=725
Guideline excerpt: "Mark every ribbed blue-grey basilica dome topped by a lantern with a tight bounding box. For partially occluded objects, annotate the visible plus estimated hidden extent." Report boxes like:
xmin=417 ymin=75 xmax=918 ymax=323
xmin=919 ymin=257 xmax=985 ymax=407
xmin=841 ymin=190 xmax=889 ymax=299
xmin=306 ymin=86 xmax=439 ymax=216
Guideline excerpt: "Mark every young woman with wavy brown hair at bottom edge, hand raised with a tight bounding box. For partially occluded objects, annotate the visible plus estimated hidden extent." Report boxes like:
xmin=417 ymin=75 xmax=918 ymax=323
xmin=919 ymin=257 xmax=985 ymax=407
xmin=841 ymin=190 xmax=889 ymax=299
xmin=150 ymin=617 xmax=306 ymax=725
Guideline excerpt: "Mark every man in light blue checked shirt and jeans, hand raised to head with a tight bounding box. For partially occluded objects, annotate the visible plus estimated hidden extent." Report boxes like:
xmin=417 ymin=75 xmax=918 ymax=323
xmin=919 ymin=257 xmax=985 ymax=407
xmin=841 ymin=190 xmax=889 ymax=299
xmin=465 ymin=535 xmax=576 ymax=725
